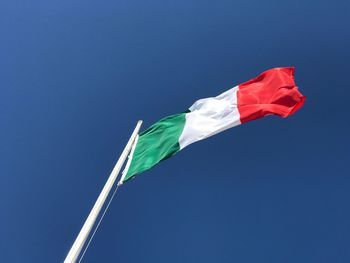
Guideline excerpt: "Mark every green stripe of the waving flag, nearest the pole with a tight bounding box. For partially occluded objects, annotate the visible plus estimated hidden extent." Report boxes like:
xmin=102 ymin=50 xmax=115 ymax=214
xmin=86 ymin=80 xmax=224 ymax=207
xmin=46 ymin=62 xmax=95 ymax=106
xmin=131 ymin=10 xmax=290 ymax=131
xmin=123 ymin=113 xmax=186 ymax=182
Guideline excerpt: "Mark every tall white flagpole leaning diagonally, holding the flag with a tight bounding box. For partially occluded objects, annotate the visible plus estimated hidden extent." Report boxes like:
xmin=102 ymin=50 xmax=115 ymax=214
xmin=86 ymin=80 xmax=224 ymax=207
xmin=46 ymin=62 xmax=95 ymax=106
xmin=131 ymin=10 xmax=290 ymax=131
xmin=64 ymin=121 xmax=142 ymax=263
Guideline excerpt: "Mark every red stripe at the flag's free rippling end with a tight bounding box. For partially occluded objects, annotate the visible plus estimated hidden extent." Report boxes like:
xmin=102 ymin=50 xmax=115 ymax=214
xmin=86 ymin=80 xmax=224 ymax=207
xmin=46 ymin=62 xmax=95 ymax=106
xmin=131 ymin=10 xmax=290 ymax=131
xmin=237 ymin=67 xmax=305 ymax=123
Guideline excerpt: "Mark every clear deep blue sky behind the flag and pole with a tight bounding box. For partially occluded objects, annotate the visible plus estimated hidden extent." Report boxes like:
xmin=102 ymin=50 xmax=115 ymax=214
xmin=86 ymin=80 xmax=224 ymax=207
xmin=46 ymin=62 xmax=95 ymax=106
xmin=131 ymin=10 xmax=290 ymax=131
xmin=0 ymin=0 xmax=350 ymax=263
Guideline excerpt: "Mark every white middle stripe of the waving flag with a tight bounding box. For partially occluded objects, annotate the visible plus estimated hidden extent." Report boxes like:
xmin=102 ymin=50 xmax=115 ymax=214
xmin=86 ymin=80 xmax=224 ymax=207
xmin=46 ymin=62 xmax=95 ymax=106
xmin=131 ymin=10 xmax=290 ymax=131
xmin=179 ymin=86 xmax=241 ymax=149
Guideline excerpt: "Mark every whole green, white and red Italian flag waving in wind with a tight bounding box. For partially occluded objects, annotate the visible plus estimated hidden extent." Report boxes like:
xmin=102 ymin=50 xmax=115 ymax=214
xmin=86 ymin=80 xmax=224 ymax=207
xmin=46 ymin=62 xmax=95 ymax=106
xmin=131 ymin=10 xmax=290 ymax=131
xmin=121 ymin=67 xmax=305 ymax=183
